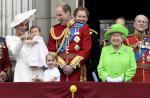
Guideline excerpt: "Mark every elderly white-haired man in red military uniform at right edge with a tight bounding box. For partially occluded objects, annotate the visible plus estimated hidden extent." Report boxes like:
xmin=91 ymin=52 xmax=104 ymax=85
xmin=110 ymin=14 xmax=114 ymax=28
xmin=125 ymin=15 xmax=150 ymax=82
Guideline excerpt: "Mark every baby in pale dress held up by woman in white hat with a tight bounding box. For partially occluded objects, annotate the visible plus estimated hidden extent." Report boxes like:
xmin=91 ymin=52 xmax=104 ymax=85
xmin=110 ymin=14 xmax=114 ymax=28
xmin=24 ymin=26 xmax=48 ymax=78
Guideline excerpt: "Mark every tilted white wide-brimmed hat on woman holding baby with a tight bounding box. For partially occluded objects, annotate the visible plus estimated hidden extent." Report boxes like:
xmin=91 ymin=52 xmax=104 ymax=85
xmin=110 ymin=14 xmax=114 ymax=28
xmin=10 ymin=9 xmax=36 ymax=28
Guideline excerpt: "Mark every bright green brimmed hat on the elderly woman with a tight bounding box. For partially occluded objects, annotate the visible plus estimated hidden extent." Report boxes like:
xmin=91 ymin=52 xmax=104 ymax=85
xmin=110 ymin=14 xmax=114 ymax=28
xmin=104 ymin=24 xmax=129 ymax=39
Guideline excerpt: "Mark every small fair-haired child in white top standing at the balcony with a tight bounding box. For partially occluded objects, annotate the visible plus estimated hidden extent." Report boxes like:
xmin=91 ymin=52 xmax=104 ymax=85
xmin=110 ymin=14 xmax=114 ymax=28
xmin=33 ymin=52 xmax=60 ymax=82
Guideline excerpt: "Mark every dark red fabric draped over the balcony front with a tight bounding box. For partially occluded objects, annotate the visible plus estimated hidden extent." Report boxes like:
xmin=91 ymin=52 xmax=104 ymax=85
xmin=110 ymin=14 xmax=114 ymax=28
xmin=0 ymin=82 xmax=150 ymax=98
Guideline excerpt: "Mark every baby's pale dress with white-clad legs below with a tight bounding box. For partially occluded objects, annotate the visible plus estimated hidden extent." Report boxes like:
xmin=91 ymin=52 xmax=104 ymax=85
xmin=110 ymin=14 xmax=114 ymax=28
xmin=28 ymin=36 xmax=48 ymax=78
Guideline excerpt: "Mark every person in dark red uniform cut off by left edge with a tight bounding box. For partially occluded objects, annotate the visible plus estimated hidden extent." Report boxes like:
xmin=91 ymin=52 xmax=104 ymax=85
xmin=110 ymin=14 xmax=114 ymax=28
xmin=0 ymin=37 xmax=11 ymax=82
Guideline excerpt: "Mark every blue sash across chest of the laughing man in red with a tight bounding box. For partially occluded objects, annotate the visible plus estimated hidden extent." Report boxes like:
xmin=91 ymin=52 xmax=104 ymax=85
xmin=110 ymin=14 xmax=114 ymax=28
xmin=60 ymin=22 xmax=84 ymax=52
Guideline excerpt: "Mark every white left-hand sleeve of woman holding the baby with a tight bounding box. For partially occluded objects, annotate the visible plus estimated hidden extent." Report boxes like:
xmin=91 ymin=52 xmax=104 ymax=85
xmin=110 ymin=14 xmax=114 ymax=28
xmin=6 ymin=35 xmax=23 ymax=55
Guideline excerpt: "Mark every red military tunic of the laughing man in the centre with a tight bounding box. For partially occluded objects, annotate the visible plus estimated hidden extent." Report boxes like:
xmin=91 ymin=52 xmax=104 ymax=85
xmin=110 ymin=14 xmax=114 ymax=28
xmin=48 ymin=21 xmax=91 ymax=82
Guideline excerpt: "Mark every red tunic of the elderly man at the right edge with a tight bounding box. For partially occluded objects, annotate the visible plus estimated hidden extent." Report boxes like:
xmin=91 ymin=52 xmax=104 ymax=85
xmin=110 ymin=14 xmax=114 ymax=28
xmin=125 ymin=34 xmax=150 ymax=82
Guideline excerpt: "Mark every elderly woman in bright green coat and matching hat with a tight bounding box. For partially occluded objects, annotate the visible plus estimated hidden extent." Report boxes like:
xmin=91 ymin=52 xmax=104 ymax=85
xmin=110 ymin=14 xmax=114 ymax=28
xmin=97 ymin=24 xmax=136 ymax=82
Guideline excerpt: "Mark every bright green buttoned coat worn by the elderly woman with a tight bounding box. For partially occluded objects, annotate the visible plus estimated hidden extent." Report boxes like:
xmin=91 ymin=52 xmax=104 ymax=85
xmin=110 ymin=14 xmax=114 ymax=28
xmin=97 ymin=44 xmax=137 ymax=82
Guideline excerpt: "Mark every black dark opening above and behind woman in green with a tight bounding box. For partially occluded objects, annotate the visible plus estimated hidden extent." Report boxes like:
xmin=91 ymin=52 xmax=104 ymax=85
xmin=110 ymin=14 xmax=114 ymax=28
xmin=85 ymin=0 xmax=150 ymax=32
